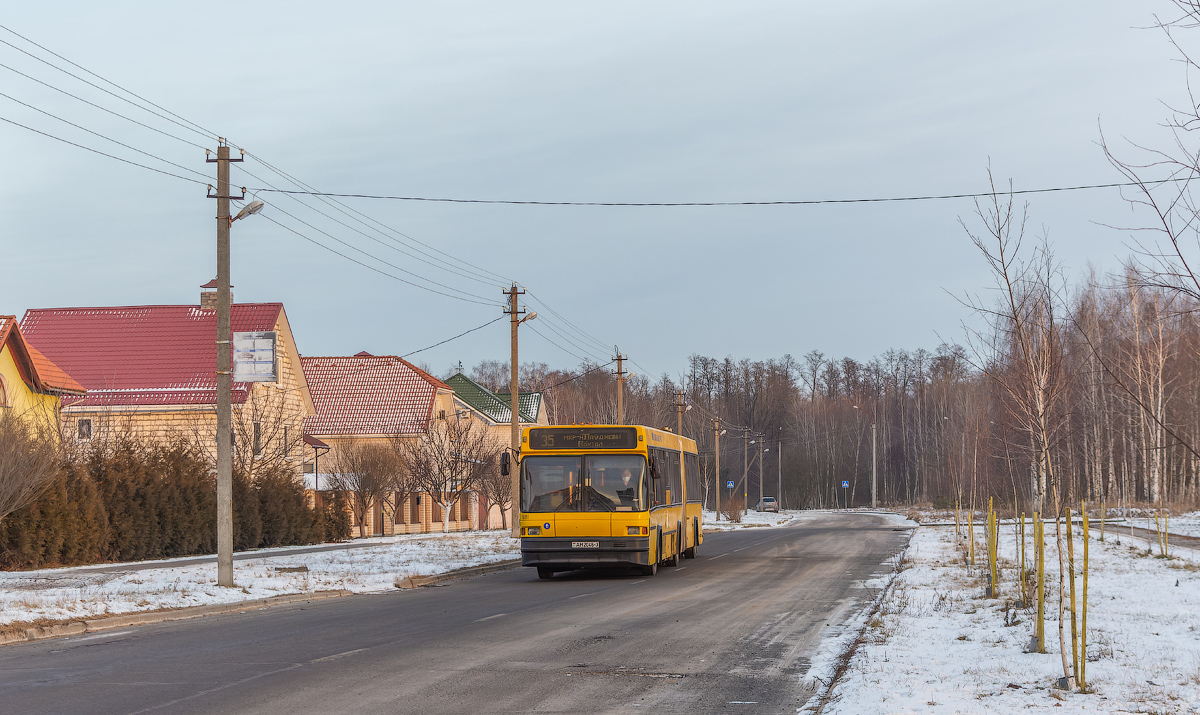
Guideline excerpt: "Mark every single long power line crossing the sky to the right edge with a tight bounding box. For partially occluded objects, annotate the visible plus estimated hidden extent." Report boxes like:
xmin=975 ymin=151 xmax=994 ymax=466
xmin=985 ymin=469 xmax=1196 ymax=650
xmin=248 ymin=178 xmax=1189 ymax=208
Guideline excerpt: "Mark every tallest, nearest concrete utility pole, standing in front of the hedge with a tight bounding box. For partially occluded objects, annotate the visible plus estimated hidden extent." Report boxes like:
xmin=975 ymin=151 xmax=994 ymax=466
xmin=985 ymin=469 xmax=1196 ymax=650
xmin=204 ymin=137 xmax=246 ymax=588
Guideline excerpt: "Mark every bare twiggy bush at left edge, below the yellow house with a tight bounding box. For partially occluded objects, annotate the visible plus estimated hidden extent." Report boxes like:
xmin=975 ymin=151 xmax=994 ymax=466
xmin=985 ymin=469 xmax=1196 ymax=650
xmin=0 ymin=408 xmax=61 ymax=519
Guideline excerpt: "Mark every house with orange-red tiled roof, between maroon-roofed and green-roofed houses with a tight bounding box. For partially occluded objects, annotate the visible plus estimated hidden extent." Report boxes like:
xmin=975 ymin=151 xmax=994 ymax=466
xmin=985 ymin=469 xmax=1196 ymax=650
xmin=301 ymin=353 xmax=482 ymax=535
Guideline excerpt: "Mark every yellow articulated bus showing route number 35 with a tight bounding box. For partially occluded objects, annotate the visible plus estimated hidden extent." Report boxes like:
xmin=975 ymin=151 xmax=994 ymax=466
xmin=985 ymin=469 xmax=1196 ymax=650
xmin=518 ymin=425 xmax=704 ymax=578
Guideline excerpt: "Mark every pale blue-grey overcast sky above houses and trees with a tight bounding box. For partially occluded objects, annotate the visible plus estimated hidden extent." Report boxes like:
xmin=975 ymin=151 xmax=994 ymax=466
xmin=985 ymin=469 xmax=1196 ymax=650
xmin=0 ymin=0 xmax=1184 ymax=375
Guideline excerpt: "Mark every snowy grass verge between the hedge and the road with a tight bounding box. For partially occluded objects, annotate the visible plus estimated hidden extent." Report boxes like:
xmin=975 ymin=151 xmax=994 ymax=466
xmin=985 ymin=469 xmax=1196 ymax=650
xmin=0 ymin=530 xmax=521 ymax=625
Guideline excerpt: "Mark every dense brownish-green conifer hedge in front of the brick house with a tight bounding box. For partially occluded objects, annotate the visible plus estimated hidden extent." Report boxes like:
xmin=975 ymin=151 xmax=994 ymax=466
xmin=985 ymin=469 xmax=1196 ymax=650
xmin=0 ymin=441 xmax=350 ymax=569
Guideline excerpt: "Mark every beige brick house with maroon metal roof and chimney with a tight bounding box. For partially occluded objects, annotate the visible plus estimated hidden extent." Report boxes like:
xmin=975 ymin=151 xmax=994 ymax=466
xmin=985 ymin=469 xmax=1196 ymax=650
xmin=20 ymin=290 xmax=314 ymax=475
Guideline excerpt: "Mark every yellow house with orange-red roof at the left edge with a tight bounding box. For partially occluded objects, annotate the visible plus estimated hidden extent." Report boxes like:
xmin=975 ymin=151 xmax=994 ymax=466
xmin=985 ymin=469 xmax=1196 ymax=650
xmin=0 ymin=316 xmax=85 ymax=432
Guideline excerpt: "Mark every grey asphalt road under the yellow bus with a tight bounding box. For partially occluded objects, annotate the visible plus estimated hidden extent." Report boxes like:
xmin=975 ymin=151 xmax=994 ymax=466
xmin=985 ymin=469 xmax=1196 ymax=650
xmin=0 ymin=515 xmax=908 ymax=715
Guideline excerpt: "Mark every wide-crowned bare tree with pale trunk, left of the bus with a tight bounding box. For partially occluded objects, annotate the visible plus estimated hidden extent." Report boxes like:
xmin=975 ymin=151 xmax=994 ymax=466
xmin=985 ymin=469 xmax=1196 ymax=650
xmin=397 ymin=420 xmax=496 ymax=531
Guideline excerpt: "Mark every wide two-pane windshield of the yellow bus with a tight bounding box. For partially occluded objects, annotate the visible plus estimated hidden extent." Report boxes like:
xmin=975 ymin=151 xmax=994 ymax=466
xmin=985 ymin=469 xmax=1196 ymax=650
xmin=521 ymin=455 xmax=648 ymax=512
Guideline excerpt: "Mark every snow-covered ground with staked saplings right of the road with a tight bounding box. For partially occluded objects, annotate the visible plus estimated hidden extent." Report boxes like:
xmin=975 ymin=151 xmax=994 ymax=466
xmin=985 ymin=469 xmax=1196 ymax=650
xmin=815 ymin=522 xmax=1200 ymax=714
